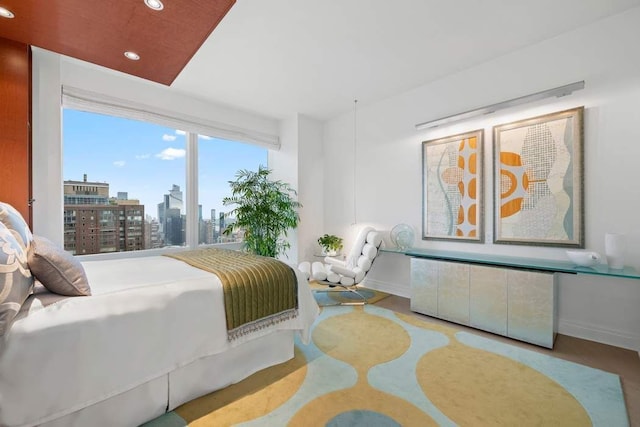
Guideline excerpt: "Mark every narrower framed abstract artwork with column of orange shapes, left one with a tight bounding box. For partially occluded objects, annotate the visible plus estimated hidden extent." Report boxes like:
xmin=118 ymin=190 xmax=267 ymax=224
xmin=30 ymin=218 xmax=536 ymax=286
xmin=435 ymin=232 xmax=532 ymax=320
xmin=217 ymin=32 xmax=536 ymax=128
xmin=422 ymin=130 xmax=484 ymax=243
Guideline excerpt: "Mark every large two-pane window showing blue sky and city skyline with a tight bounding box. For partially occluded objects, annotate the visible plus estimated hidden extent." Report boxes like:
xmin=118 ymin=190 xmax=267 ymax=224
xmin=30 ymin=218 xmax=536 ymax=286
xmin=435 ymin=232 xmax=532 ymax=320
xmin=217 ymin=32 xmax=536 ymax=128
xmin=63 ymin=108 xmax=267 ymax=255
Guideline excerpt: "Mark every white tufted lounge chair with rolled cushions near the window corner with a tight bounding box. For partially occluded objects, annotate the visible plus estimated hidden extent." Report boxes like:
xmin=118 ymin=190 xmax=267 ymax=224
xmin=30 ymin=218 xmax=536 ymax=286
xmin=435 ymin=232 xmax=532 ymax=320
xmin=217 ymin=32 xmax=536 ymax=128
xmin=298 ymin=227 xmax=382 ymax=305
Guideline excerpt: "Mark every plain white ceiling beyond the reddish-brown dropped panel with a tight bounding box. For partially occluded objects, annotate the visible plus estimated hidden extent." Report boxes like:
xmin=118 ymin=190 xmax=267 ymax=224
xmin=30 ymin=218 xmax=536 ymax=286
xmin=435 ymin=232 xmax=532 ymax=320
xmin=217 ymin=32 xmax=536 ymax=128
xmin=172 ymin=0 xmax=640 ymax=120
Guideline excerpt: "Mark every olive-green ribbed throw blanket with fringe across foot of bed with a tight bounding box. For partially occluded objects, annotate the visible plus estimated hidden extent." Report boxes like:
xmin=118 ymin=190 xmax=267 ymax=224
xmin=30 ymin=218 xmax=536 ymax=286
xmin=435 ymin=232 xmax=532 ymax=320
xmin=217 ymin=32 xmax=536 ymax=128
xmin=166 ymin=248 xmax=298 ymax=340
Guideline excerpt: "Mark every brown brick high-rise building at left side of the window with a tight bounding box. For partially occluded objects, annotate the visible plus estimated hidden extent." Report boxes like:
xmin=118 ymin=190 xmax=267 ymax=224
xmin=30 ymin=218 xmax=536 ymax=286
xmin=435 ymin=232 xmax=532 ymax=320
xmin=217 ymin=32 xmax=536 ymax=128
xmin=64 ymin=174 xmax=145 ymax=255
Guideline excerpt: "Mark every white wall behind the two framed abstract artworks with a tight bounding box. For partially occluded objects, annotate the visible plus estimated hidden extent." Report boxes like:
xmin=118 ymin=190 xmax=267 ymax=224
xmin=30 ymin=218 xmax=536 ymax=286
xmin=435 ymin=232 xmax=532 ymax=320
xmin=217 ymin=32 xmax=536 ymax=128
xmin=324 ymin=8 xmax=640 ymax=349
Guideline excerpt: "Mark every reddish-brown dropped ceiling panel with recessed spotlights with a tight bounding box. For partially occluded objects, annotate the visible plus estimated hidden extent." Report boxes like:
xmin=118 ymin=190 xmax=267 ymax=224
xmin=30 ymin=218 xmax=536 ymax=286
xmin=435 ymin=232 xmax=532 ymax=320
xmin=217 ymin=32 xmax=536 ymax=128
xmin=0 ymin=0 xmax=235 ymax=85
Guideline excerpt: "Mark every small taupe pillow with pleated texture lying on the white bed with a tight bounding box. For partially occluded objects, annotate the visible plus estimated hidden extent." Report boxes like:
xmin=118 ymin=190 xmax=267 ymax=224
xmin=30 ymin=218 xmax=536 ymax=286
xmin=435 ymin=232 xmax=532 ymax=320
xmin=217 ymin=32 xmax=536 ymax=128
xmin=27 ymin=235 xmax=91 ymax=297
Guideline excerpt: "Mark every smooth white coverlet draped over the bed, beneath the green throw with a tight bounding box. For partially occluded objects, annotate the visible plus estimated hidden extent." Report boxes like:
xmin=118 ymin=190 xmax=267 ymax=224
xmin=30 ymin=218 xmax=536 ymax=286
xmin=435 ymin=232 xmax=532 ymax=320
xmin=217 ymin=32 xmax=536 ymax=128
xmin=0 ymin=256 xmax=318 ymax=425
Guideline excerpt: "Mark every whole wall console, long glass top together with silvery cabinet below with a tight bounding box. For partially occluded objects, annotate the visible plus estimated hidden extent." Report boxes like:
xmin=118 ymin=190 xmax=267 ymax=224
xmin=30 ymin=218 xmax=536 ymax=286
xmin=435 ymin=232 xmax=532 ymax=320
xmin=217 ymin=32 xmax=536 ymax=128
xmin=382 ymin=248 xmax=640 ymax=348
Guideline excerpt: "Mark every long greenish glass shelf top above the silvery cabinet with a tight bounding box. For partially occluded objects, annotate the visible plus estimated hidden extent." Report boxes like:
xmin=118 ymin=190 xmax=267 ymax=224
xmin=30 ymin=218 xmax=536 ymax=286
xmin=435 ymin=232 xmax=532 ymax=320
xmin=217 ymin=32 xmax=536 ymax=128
xmin=383 ymin=248 xmax=640 ymax=279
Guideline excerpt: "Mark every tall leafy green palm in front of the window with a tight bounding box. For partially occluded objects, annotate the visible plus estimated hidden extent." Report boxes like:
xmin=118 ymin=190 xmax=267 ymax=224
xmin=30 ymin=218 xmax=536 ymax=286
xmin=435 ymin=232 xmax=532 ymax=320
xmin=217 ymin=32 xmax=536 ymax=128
xmin=222 ymin=165 xmax=302 ymax=257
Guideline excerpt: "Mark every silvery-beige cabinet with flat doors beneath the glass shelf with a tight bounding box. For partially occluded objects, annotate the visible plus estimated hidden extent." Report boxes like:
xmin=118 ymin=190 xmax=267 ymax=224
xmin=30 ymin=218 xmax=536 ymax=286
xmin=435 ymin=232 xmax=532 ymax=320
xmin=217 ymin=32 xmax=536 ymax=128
xmin=411 ymin=258 xmax=556 ymax=348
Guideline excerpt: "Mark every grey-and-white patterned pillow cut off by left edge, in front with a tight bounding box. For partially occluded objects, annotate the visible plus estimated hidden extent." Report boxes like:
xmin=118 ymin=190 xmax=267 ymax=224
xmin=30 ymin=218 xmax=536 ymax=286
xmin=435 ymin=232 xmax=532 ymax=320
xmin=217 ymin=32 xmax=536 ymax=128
xmin=0 ymin=223 xmax=33 ymax=337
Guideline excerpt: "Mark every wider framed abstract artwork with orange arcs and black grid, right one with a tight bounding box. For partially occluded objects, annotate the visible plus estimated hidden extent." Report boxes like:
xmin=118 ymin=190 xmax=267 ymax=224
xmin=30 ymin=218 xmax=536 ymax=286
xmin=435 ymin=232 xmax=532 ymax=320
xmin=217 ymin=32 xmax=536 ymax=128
xmin=493 ymin=107 xmax=584 ymax=248
